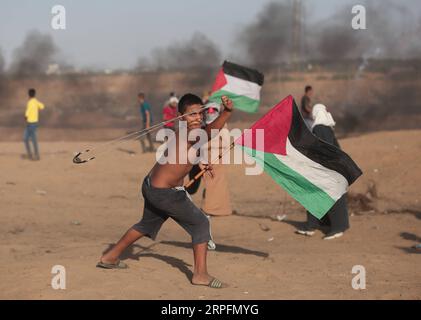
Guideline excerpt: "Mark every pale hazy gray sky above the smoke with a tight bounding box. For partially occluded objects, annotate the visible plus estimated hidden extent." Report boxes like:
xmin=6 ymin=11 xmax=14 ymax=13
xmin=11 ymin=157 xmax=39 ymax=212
xmin=0 ymin=0 xmax=421 ymax=68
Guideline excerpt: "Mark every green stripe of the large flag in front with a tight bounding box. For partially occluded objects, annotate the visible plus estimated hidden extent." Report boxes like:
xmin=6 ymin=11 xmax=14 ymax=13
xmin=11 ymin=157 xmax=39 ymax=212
xmin=242 ymin=146 xmax=335 ymax=219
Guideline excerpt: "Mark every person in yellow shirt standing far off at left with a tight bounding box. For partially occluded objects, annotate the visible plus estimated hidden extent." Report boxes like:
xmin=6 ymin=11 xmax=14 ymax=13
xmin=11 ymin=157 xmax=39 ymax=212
xmin=23 ymin=89 xmax=44 ymax=160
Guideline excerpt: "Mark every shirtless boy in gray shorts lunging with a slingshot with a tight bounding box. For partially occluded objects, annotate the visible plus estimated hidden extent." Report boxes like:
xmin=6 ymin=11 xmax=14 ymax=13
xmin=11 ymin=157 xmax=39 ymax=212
xmin=97 ymin=93 xmax=233 ymax=288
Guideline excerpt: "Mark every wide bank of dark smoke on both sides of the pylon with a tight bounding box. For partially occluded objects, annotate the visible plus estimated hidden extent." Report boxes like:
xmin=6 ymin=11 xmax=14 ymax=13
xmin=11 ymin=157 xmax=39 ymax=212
xmin=237 ymin=0 xmax=421 ymax=66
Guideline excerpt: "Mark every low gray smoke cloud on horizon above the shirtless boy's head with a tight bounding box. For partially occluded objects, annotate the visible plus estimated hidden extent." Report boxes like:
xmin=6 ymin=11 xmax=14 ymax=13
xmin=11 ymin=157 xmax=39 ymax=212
xmin=139 ymin=32 xmax=221 ymax=70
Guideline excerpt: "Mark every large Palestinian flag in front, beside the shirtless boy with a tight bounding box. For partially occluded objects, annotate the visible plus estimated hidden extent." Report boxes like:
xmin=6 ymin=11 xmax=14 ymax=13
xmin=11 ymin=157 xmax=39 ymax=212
xmin=235 ymin=96 xmax=362 ymax=219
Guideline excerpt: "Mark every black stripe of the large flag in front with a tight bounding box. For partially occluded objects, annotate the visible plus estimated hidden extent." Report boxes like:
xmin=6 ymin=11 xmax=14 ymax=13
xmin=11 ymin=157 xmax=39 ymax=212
xmin=288 ymin=101 xmax=362 ymax=185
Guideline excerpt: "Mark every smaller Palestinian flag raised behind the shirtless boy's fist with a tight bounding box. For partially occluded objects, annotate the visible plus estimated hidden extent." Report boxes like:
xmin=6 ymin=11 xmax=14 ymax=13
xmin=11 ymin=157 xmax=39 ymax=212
xmin=209 ymin=61 xmax=264 ymax=112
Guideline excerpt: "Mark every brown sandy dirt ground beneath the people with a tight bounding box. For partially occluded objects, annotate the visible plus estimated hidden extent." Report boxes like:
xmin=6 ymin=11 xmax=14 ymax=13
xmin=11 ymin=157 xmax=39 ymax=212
xmin=0 ymin=128 xmax=421 ymax=299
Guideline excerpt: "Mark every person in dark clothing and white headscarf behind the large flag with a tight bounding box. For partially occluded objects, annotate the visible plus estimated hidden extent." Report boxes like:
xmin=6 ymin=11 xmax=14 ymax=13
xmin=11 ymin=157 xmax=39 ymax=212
xmin=297 ymin=104 xmax=349 ymax=240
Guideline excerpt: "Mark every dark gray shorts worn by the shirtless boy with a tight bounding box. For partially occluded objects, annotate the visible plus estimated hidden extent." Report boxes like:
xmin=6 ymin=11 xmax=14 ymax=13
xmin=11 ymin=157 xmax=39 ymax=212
xmin=132 ymin=175 xmax=212 ymax=244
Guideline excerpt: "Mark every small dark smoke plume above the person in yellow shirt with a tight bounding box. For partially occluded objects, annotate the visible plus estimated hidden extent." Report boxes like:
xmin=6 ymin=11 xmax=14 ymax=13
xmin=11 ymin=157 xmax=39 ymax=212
xmin=11 ymin=31 xmax=58 ymax=75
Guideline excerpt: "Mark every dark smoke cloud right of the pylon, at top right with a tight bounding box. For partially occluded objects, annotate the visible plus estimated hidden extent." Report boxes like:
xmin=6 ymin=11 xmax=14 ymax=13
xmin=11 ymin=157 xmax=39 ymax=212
xmin=306 ymin=0 xmax=421 ymax=60
